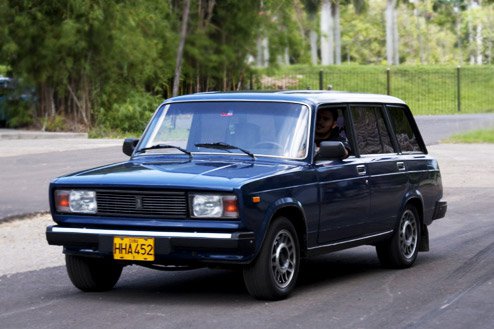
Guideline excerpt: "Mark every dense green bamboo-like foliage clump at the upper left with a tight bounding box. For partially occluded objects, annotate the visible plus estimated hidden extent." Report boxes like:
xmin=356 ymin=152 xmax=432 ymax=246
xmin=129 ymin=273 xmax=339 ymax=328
xmin=0 ymin=0 xmax=173 ymax=127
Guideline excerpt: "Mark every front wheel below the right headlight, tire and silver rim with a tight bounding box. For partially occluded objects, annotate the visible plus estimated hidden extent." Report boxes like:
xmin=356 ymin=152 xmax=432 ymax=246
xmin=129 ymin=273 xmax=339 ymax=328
xmin=243 ymin=217 xmax=300 ymax=300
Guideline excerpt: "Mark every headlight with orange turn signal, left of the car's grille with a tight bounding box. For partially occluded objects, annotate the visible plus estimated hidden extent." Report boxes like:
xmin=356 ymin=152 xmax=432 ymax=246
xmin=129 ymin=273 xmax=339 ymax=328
xmin=55 ymin=190 xmax=98 ymax=214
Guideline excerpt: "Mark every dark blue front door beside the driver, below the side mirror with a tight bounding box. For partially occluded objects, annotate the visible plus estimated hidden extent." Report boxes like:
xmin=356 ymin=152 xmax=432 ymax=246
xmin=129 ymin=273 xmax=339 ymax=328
xmin=316 ymin=106 xmax=370 ymax=244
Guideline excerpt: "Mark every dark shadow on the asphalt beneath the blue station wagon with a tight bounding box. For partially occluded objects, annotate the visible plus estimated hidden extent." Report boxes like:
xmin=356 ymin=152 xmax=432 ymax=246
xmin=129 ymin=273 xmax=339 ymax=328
xmin=79 ymin=247 xmax=385 ymax=304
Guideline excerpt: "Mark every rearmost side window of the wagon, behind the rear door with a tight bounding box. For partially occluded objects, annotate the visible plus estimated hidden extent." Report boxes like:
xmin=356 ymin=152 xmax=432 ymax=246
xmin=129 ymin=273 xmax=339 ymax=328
xmin=387 ymin=106 xmax=422 ymax=152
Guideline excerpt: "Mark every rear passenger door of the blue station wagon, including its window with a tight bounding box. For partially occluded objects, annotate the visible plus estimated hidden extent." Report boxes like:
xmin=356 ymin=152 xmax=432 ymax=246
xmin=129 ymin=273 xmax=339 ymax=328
xmin=351 ymin=104 xmax=408 ymax=235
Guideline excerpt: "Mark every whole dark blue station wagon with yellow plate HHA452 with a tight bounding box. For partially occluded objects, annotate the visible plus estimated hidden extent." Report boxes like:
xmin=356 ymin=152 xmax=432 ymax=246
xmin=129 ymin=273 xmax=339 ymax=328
xmin=46 ymin=91 xmax=447 ymax=300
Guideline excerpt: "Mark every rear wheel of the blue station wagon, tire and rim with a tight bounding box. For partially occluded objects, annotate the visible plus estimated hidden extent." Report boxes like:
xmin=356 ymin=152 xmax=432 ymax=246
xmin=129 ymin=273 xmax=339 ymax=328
xmin=376 ymin=205 xmax=421 ymax=268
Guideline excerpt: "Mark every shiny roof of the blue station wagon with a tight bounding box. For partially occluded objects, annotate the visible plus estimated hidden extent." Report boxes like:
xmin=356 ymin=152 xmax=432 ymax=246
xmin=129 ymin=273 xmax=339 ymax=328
xmin=165 ymin=90 xmax=405 ymax=106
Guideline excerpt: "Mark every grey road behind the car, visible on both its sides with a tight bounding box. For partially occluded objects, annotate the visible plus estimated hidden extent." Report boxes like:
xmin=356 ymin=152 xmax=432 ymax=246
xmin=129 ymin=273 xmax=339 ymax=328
xmin=0 ymin=114 xmax=494 ymax=222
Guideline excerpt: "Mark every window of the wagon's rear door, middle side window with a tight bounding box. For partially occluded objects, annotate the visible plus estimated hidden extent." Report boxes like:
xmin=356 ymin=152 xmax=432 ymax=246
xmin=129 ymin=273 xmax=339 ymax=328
xmin=351 ymin=105 xmax=394 ymax=154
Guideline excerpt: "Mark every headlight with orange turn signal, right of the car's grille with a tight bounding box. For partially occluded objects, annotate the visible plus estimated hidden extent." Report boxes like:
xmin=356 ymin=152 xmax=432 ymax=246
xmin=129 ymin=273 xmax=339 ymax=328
xmin=190 ymin=194 xmax=238 ymax=218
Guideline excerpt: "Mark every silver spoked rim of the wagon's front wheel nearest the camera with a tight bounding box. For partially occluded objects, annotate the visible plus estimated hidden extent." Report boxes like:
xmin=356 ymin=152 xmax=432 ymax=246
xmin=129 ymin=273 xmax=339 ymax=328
xmin=271 ymin=230 xmax=296 ymax=288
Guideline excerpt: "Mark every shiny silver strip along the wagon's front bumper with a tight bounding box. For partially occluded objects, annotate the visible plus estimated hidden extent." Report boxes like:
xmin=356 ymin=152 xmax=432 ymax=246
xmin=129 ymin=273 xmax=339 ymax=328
xmin=51 ymin=226 xmax=233 ymax=239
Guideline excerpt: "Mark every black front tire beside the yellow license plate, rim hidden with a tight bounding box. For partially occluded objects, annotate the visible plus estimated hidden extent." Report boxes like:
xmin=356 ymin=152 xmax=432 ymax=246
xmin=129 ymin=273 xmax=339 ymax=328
xmin=65 ymin=255 xmax=123 ymax=292
